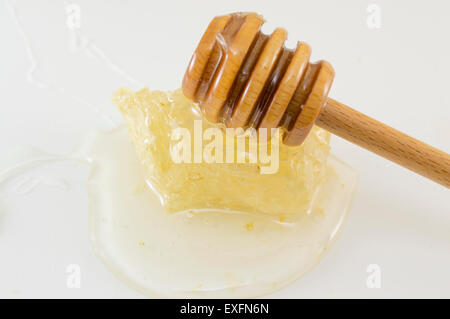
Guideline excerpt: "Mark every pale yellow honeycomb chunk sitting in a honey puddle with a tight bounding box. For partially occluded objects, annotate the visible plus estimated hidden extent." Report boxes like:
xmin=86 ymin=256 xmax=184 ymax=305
xmin=113 ymin=88 xmax=330 ymax=218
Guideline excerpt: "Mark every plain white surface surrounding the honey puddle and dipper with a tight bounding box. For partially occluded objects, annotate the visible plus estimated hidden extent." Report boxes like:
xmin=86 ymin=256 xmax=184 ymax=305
xmin=0 ymin=0 xmax=450 ymax=298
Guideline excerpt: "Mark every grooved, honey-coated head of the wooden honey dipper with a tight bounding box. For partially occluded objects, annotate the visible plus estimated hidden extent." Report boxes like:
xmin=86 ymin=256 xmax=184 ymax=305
xmin=182 ymin=13 xmax=334 ymax=145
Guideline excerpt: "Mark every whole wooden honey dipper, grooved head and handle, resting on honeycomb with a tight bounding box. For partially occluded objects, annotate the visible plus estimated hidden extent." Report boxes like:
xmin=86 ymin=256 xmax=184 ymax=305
xmin=182 ymin=13 xmax=450 ymax=188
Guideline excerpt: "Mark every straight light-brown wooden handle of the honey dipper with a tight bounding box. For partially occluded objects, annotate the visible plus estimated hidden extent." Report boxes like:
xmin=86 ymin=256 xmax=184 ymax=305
xmin=315 ymin=98 xmax=450 ymax=188
